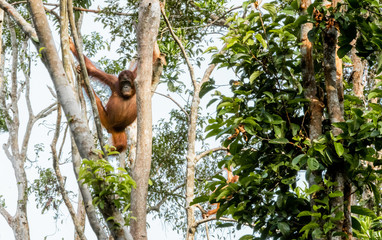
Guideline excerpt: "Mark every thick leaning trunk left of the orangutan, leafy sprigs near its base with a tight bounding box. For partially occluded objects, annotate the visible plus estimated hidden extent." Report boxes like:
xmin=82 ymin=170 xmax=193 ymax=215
xmin=26 ymin=0 xmax=121 ymax=240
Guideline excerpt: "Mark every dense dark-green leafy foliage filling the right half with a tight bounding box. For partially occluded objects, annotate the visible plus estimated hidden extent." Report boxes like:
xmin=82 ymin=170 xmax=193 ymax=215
xmin=198 ymin=0 xmax=382 ymax=239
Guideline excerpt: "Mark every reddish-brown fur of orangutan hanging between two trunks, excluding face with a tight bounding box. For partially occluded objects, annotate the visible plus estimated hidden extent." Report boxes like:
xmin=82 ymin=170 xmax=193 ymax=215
xmin=70 ymin=41 xmax=160 ymax=152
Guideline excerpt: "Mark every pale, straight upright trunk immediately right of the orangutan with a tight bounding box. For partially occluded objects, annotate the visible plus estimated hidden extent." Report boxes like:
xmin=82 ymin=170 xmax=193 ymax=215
xmin=131 ymin=0 xmax=160 ymax=240
